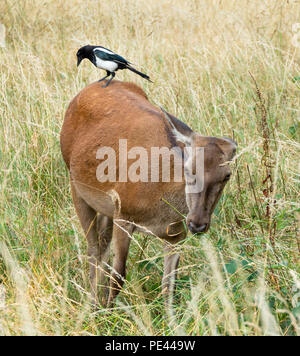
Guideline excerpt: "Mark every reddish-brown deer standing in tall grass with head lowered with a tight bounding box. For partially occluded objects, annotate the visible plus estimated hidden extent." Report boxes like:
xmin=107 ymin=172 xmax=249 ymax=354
xmin=60 ymin=81 xmax=237 ymax=307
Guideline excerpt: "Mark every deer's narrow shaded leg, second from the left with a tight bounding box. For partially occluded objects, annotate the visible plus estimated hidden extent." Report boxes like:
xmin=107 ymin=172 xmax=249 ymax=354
xmin=97 ymin=215 xmax=113 ymax=306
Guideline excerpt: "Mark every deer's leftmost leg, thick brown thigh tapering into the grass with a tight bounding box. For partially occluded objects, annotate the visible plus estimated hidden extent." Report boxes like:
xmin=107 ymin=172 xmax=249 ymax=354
xmin=71 ymin=183 xmax=100 ymax=305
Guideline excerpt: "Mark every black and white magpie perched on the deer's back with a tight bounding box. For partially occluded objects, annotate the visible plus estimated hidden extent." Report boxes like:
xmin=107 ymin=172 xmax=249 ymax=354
xmin=77 ymin=45 xmax=151 ymax=88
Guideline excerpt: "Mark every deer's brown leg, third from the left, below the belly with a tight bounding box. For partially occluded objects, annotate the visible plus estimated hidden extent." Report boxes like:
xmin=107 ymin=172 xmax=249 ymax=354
xmin=107 ymin=222 xmax=132 ymax=306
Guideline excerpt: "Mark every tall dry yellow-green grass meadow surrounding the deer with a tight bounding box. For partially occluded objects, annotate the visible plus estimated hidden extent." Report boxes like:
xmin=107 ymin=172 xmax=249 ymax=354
xmin=0 ymin=0 xmax=300 ymax=336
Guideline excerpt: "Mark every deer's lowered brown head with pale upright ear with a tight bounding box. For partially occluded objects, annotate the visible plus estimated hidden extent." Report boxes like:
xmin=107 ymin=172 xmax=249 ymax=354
xmin=163 ymin=110 xmax=237 ymax=234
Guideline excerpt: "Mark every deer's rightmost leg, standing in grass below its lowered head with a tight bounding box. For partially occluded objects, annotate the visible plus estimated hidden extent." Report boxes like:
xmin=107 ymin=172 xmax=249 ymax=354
xmin=162 ymin=243 xmax=180 ymax=307
